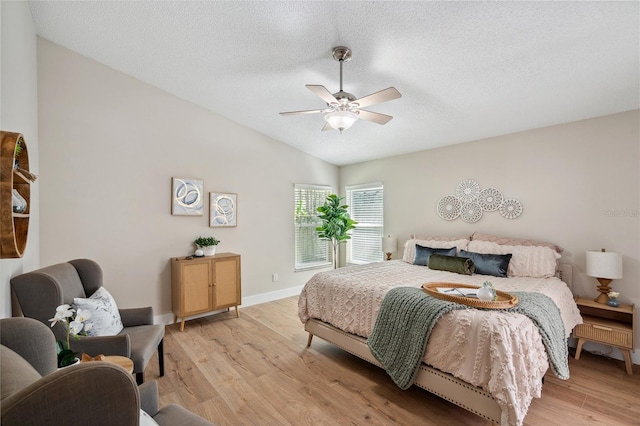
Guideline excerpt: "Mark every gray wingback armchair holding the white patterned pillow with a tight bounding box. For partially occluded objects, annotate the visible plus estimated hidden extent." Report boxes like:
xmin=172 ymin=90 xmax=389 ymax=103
xmin=11 ymin=259 xmax=164 ymax=384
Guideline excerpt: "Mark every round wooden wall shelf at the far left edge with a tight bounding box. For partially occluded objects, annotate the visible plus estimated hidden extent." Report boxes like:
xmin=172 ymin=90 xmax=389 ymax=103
xmin=0 ymin=131 xmax=36 ymax=259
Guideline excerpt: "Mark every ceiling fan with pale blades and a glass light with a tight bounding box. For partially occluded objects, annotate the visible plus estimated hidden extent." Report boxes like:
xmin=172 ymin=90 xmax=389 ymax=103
xmin=280 ymin=46 xmax=402 ymax=133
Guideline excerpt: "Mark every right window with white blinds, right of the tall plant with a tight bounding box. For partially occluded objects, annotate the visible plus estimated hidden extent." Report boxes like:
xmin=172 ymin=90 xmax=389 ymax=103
xmin=346 ymin=182 xmax=384 ymax=264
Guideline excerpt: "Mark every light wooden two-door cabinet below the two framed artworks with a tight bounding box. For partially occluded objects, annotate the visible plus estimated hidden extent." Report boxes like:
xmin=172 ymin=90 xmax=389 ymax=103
xmin=171 ymin=253 xmax=242 ymax=331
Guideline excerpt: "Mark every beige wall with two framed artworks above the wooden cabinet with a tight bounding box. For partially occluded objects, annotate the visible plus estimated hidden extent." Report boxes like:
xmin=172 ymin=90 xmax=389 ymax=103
xmin=38 ymin=39 xmax=338 ymax=317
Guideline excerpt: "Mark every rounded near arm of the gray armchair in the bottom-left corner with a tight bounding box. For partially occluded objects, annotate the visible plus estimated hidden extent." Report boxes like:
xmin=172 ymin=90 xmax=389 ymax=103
xmin=1 ymin=362 xmax=140 ymax=426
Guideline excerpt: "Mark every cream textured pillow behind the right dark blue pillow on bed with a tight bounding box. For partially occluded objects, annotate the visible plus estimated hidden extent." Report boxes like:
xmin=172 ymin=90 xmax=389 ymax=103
xmin=468 ymin=240 xmax=561 ymax=278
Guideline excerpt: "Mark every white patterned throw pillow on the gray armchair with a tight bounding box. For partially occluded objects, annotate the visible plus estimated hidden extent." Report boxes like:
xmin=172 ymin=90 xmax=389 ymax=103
xmin=73 ymin=287 xmax=124 ymax=336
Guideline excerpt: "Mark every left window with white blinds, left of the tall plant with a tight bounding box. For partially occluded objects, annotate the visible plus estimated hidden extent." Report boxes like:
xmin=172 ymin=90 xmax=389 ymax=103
xmin=294 ymin=184 xmax=332 ymax=271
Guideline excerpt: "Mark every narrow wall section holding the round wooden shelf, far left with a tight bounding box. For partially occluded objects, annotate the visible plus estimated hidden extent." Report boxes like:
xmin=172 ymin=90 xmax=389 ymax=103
xmin=0 ymin=2 xmax=40 ymax=318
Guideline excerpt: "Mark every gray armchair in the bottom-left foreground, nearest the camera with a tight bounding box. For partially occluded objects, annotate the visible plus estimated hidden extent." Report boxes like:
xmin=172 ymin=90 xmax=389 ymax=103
xmin=0 ymin=318 xmax=211 ymax=426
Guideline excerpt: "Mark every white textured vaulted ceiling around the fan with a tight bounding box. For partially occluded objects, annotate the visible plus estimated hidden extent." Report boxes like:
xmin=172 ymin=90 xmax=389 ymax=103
xmin=30 ymin=1 xmax=640 ymax=165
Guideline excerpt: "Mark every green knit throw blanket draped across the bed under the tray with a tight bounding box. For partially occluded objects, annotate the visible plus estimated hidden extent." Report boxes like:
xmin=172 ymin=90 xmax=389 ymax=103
xmin=367 ymin=287 xmax=569 ymax=389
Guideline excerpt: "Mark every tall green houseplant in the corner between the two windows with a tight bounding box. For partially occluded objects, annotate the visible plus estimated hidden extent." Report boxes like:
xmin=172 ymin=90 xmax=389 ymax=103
xmin=316 ymin=194 xmax=358 ymax=269
